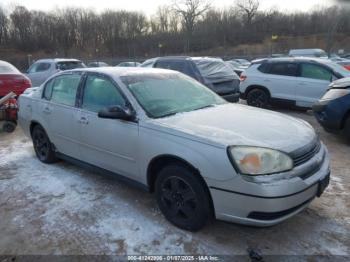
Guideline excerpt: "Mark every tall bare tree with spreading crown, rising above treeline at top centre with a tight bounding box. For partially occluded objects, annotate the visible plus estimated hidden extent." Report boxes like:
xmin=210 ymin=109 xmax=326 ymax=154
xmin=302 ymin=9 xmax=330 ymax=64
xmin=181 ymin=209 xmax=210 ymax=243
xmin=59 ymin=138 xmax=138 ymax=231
xmin=173 ymin=0 xmax=210 ymax=52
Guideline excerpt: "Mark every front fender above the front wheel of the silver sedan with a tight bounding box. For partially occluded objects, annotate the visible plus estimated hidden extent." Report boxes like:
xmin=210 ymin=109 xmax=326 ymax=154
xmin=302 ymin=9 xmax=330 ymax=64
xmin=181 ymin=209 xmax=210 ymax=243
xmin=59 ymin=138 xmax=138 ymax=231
xmin=139 ymin=127 xmax=236 ymax=184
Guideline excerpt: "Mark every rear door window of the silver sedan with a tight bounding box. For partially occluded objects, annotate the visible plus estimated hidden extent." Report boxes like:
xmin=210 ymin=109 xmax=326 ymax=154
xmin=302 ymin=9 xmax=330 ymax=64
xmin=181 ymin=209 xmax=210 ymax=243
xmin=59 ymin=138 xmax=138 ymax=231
xmin=50 ymin=74 xmax=81 ymax=106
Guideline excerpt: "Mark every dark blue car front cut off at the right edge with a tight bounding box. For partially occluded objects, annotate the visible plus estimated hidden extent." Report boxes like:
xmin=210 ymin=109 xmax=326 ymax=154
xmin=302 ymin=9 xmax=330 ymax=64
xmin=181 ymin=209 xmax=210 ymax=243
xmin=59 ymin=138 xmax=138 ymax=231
xmin=313 ymin=78 xmax=350 ymax=140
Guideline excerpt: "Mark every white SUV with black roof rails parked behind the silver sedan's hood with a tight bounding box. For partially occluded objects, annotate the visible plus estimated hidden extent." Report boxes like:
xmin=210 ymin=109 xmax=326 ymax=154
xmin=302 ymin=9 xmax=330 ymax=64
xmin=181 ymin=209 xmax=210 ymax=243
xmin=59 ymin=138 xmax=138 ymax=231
xmin=240 ymin=58 xmax=350 ymax=109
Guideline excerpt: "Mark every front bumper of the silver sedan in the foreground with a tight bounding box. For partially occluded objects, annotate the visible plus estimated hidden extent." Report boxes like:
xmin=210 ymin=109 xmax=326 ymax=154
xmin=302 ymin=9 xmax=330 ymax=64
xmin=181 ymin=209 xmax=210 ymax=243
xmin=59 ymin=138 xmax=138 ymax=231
xmin=210 ymin=142 xmax=330 ymax=227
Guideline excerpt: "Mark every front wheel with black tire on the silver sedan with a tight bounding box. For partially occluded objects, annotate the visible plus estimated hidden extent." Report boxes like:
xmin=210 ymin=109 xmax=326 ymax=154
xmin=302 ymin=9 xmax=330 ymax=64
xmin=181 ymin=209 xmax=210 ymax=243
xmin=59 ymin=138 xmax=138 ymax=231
xmin=155 ymin=164 xmax=212 ymax=231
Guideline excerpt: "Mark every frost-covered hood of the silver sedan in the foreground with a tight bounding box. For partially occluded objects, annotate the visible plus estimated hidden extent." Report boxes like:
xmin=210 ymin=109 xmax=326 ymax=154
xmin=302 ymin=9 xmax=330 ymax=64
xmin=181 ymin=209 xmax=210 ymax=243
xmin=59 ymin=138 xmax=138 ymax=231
xmin=152 ymin=104 xmax=316 ymax=153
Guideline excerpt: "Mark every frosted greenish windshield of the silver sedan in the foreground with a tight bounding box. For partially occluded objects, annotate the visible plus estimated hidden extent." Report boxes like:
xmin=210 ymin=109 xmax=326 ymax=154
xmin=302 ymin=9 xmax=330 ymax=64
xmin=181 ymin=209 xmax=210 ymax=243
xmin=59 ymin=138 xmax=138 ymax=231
xmin=121 ymin=73 xmax=227 ymax=118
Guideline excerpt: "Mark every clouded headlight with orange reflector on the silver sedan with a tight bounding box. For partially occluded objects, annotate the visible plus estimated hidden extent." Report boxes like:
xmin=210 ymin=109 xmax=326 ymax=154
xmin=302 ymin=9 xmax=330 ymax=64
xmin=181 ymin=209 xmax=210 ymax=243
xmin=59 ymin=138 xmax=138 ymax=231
xmin=228 ymin=146 xmax=294 ymax=175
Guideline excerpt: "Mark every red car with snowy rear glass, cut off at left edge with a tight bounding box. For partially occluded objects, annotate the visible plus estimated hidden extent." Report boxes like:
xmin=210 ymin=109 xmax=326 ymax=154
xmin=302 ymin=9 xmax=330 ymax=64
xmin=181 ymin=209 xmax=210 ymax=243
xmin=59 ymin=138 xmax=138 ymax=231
xmin=0 ymin=60 xmax=32 ymax=98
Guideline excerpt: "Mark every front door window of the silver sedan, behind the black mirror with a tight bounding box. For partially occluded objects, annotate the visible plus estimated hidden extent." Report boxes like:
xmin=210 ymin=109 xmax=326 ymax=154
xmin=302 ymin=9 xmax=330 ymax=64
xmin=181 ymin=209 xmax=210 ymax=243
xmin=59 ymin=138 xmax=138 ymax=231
xmin=82 ymin=75 xmax=125 ymax=112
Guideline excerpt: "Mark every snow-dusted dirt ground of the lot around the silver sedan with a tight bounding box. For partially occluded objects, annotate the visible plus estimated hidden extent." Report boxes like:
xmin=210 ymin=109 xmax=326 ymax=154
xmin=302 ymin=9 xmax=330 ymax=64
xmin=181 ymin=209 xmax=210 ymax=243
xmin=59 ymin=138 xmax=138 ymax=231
xmin=0 ymin=107 xmax=350 ymax=256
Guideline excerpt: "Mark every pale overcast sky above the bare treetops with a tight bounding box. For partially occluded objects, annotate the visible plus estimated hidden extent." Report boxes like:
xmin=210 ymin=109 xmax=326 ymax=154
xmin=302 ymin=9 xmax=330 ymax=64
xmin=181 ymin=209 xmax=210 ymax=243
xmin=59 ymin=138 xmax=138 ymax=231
xmin=0 ymin=0 xmax=347 ymax=15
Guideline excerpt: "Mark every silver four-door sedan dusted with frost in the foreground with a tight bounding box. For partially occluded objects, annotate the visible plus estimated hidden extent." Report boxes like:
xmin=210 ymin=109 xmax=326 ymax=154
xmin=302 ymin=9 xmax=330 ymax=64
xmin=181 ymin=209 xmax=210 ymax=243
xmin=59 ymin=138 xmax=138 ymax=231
xmin=19 ymin=68 xmax=330 ymax=231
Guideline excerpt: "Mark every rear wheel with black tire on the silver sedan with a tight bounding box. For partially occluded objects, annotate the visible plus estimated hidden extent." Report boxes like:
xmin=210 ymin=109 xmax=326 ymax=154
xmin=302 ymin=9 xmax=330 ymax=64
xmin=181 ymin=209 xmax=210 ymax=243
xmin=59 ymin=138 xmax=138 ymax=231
xmin=32 ymin=125 xmax=57 ymax=164
